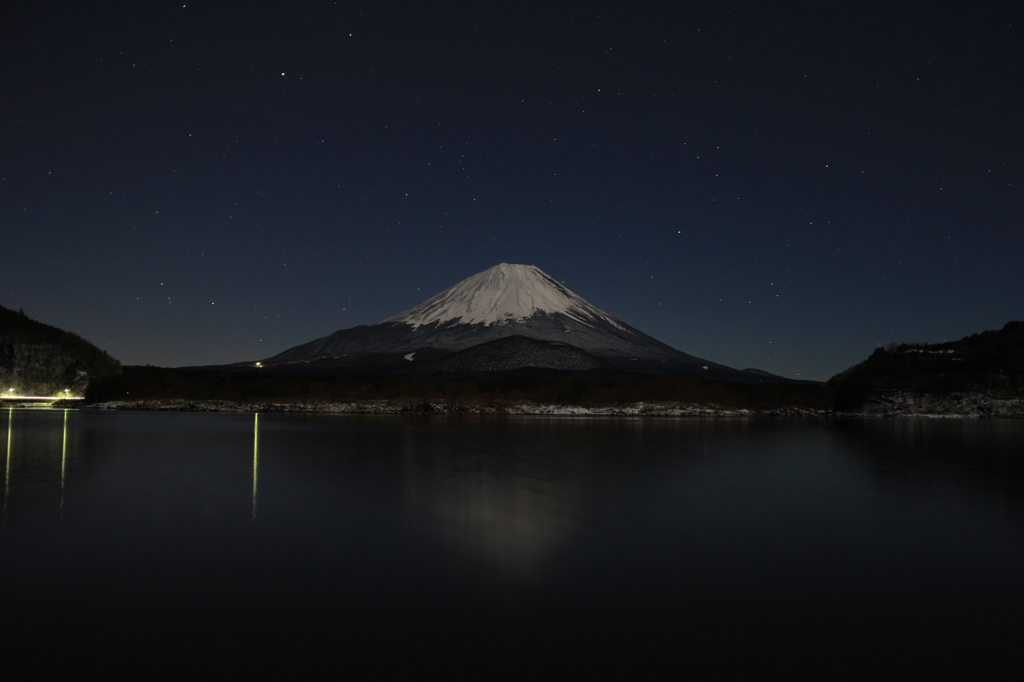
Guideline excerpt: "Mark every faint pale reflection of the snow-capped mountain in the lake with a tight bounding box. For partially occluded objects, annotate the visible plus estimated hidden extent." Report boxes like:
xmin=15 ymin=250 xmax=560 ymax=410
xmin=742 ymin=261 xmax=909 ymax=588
xmin=402 ymin=418 xmax=765 ymax=580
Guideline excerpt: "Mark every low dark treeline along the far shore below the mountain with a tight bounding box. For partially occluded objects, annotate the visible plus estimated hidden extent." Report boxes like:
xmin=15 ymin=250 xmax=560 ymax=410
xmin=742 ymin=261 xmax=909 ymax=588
xmin=86 ymin=366 xmax=831 ymax=410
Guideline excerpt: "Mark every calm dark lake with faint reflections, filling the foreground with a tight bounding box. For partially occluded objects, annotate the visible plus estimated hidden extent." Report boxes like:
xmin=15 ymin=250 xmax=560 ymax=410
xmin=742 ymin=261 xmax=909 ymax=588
xmin=0 ymin=410 xmax=1024 ymax=680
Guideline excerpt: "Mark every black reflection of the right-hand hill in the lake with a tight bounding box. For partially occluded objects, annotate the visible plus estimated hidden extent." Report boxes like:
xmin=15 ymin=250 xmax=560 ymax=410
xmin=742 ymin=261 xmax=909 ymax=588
xmin=837 ymin=418 xmax=1024 ymax=523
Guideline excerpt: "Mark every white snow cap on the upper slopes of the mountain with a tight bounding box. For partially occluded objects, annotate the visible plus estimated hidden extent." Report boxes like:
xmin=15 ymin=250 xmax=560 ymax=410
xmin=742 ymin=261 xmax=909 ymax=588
xmin=380 ymin=263 xmax=626 ymax=331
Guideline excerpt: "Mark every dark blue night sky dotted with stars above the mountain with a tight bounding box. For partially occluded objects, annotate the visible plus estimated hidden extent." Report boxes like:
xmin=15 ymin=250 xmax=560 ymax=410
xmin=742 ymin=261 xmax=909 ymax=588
xmin=0 ymin=0 xmax=1024 ymax=380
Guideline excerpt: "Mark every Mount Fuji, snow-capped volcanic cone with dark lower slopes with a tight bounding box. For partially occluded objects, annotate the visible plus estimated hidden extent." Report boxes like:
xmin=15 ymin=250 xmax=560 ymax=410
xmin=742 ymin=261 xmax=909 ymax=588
xmin=261 ymin=263 xmax=781 ymax=381
